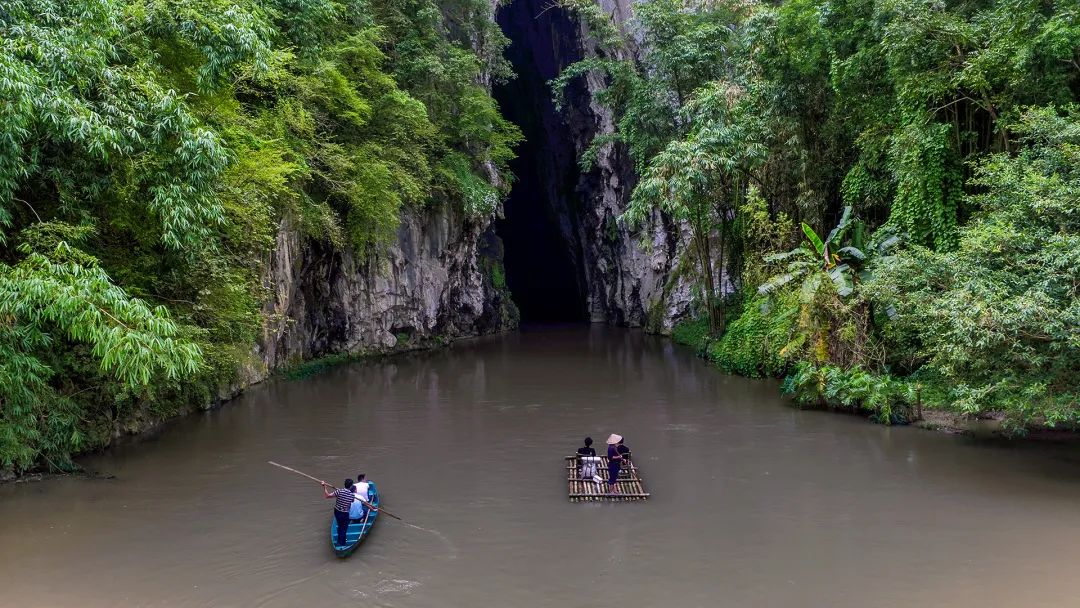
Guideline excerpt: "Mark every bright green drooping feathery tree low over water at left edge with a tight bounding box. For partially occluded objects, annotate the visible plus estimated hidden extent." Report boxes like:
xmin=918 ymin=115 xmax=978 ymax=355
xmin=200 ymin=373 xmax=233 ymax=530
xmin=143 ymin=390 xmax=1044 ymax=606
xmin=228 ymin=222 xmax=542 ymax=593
xmin=0 ymin=222 xmax=202 ymax=469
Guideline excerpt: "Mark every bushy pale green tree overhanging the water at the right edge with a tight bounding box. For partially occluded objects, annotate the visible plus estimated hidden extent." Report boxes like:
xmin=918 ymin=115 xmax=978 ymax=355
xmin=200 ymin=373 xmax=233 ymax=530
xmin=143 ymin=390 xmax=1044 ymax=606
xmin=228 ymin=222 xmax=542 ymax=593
xmin=869 ymin=106 xmax=1080 ymax=424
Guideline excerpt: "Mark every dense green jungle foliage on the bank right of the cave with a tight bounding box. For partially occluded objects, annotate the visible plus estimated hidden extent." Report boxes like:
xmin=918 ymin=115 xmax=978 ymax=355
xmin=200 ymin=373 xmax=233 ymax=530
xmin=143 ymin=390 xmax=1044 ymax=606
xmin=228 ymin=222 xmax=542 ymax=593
xmin=556 ymin=0 xmax=1080 ymax=431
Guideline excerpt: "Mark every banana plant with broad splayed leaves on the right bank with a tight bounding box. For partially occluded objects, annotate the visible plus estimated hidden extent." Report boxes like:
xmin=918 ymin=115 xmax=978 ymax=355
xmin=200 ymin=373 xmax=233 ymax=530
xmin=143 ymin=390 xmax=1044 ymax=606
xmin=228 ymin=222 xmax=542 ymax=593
xmin=757 ymin=206 xmax=866 ymax=303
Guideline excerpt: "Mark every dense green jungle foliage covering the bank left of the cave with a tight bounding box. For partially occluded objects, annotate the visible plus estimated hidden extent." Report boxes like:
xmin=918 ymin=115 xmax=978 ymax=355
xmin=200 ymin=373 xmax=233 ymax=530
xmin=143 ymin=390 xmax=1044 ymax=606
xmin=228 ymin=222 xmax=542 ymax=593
xmin=0 ymin=0 xmax=519 ymax=471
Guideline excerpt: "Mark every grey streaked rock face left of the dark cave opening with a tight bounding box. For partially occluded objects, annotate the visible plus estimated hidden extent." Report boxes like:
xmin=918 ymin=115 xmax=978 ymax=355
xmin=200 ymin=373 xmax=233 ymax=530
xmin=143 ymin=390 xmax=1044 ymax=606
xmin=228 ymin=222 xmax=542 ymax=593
xmin=238 ymin=207 xmax=517 ymax=388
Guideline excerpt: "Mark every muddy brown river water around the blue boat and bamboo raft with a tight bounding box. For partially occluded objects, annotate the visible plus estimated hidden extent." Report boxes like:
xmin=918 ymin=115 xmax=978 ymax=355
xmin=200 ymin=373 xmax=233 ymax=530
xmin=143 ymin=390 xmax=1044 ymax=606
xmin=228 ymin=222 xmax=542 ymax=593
xmin=0 ymin=326 xmax=1080 ymax=608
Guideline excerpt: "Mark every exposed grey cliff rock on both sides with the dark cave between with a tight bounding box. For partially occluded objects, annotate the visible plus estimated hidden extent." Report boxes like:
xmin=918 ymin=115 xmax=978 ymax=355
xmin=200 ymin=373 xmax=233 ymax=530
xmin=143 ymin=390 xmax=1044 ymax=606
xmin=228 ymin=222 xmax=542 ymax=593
xmin=249 ymin=0 xmax=689 ymax=386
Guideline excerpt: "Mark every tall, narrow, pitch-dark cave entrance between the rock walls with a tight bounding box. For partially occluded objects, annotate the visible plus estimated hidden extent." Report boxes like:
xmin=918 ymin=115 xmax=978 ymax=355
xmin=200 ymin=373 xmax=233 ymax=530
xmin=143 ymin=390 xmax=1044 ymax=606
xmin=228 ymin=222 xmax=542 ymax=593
xmin=494 ymin=0 xmax=588 ymax=322
